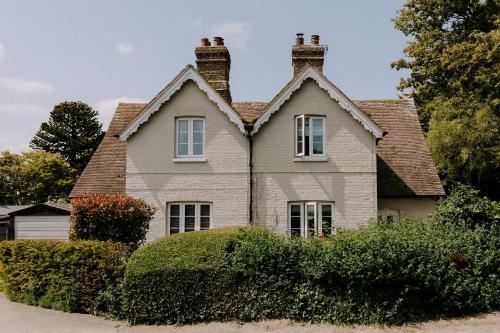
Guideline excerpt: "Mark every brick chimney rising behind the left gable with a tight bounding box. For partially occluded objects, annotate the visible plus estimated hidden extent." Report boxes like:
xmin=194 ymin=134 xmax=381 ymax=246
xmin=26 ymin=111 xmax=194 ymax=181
xmin=195 ymin=37 xmax=232 ymax=104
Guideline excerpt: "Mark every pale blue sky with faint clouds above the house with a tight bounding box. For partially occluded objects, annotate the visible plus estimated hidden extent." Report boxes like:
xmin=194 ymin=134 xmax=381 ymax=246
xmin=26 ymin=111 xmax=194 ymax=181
xmin=0 ymin=0 xmax=407 ymax=153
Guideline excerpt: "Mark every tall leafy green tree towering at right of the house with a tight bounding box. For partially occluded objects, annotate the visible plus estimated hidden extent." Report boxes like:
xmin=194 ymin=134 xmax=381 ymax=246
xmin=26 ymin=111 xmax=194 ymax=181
xmin=392 ymin=0 xmax=500 ymax=199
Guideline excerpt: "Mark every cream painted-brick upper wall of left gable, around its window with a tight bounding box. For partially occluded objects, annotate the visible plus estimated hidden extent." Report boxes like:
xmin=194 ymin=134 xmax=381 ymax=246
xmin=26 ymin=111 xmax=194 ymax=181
xmin=122 ymin=81 xmax=248 ymax=174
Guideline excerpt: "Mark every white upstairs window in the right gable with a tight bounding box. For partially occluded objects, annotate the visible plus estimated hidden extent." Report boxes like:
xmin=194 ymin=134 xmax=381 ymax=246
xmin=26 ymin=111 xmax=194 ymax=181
xmin=295 ymin=115 xmax=325 ymax=156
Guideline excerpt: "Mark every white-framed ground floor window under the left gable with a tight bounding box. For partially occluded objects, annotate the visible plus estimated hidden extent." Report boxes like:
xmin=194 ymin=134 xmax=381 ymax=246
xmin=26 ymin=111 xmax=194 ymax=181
xmin=167 ymin=202 xmax=212 ymax=235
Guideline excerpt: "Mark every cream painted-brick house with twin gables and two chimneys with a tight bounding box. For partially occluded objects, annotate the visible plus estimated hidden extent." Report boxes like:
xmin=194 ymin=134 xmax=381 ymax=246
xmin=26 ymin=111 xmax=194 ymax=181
xmin=70 ymin=34 xmax=445 ymax=240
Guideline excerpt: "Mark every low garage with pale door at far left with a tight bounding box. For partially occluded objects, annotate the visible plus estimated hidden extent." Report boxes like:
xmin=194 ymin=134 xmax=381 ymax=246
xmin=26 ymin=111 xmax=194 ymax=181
xmin=0 ymin=202 xmax=70 ymax=240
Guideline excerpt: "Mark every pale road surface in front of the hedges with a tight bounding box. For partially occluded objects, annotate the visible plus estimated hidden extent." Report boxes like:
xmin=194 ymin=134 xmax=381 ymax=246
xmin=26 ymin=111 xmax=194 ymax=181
xmin=0 ymin=293 xmax=500 ymax=333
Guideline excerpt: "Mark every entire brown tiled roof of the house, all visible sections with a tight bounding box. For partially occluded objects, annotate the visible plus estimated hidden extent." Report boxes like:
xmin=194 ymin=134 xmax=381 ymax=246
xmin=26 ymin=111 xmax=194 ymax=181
xmin=70 ymin=99 xmax=445 ymax=197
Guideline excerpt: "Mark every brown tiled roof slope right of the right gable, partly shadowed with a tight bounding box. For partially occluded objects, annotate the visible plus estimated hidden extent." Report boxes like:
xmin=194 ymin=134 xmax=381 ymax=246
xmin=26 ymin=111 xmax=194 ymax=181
xmin=354 ymin=99 xmax=445 ymax=197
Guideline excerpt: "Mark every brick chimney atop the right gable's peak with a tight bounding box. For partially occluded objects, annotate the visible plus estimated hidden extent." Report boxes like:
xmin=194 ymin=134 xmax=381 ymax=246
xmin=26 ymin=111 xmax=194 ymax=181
xmin=292 ymin=33 xmax=326 ymax=77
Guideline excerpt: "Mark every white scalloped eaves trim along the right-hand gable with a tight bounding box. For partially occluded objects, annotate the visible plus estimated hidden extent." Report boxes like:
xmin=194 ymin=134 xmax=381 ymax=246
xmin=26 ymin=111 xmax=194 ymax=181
xmin=251 ymin=67 xmax=384 ymax=139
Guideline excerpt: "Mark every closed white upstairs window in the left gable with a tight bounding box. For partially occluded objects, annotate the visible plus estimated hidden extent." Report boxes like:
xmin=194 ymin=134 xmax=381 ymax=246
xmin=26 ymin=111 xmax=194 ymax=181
xmin=176 ymin=118 xmax=205 ymax=157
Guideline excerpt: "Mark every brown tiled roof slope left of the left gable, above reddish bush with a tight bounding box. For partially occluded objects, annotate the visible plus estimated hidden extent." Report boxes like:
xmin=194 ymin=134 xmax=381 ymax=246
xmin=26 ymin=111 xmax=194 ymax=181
xmin=70 ymin=103 xmax=146 ymax=198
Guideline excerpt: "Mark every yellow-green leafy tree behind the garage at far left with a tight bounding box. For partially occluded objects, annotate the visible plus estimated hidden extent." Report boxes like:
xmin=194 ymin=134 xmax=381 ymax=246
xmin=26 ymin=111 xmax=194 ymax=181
xmin=0 ymin=150 xmax=76 ymax=205
